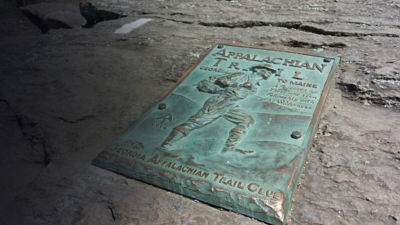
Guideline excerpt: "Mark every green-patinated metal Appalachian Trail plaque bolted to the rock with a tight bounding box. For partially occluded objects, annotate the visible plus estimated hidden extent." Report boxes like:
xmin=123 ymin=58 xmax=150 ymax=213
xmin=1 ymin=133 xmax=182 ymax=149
xmin=93 ymin=45 xmax=339 ymax=224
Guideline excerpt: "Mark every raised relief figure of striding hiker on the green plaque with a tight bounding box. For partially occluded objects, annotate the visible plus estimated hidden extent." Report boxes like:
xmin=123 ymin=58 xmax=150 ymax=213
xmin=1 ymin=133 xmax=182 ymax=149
xmin=161 ymin=65 xmax=281 ymax=154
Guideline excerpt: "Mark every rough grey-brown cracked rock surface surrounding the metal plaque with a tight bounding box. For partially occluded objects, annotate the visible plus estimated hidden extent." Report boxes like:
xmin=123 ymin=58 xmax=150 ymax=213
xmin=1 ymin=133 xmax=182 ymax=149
xmin=0 ymin=0 xmax=400 ymax=225
